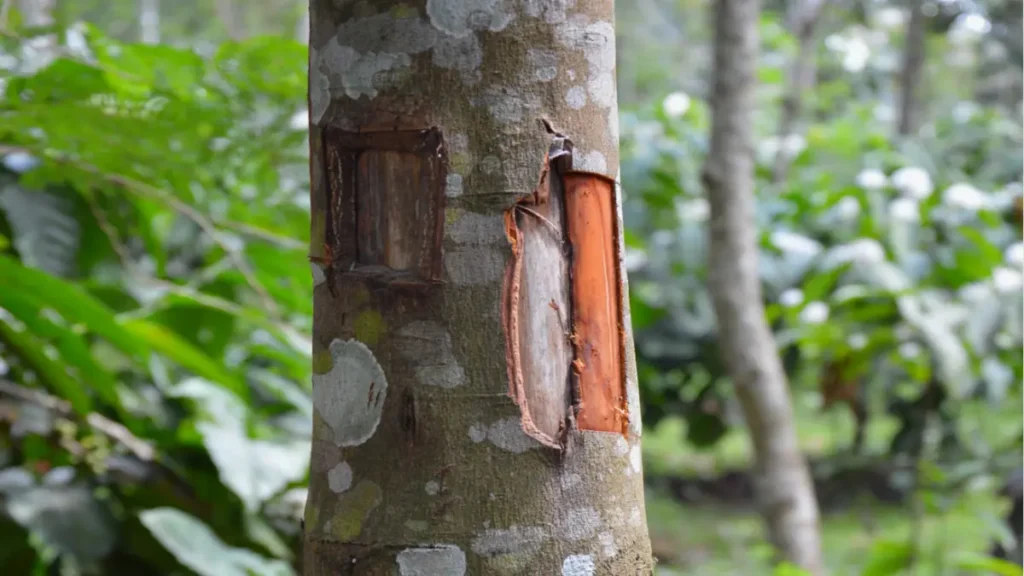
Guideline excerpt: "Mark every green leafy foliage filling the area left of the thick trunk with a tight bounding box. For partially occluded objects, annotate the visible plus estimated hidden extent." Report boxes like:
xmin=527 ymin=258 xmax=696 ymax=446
xmin=0 ymin=21 xmax=312 ymax=576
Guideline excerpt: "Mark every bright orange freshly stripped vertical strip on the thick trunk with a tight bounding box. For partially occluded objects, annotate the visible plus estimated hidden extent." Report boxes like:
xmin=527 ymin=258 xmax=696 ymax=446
xmin=563 ymin=172 xmax=629 ymax=434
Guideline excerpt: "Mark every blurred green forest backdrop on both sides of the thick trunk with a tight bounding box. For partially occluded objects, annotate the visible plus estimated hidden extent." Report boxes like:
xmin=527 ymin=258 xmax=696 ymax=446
xmin=0 ymin=0 xmax=1024 ymax=576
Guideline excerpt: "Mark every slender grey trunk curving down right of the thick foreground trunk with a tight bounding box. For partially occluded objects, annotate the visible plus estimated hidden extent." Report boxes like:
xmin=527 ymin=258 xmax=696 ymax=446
xmin=703 ymin=0 xmax=823 ymax=574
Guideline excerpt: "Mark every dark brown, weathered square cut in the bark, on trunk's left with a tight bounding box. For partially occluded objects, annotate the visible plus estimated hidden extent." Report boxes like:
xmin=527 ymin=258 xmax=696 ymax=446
xmin=323 ymin=126 xmax=447 ymax=282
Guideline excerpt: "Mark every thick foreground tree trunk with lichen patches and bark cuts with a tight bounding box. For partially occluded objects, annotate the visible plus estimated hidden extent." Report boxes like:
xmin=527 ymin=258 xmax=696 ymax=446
xmin=303 ymin=0 xmax=652 ymax=576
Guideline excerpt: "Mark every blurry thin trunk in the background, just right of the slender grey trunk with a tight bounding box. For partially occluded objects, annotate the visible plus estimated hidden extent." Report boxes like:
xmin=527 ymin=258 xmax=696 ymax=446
xmin=772 ymin=0 xmax=826 ymax=183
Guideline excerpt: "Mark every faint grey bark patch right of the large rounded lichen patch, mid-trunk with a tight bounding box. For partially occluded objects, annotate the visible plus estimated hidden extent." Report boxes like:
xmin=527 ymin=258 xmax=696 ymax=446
xmin=395 ymin=321 xmax=466 ymax=388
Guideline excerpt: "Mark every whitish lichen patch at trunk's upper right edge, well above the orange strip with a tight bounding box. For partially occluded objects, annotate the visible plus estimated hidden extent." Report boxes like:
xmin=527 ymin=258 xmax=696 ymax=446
xmin=557 ymin=14 xmax=615 ymax=108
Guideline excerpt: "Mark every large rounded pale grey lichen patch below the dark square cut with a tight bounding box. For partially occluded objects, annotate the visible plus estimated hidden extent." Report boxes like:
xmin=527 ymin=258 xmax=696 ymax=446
xmin=313 ymin=339 xmax=387 ymax=447
